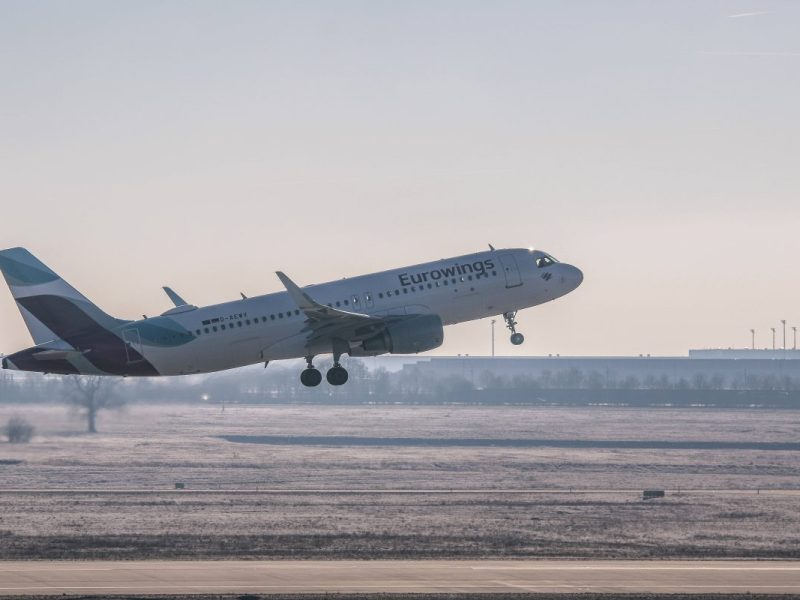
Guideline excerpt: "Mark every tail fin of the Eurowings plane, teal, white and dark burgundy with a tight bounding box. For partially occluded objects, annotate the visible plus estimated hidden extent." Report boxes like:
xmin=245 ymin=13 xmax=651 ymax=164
xmin=0 ymin=248 xmax=122 ymax=345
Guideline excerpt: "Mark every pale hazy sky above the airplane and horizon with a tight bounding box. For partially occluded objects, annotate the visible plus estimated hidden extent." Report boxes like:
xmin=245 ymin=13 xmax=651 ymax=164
xmin=0 ymin=0 xmax=800 ymax=354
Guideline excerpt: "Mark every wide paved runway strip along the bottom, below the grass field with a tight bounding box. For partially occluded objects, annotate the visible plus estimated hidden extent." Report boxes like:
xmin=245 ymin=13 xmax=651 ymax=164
xmin=0 ymin=560 xmax=800 ymax=595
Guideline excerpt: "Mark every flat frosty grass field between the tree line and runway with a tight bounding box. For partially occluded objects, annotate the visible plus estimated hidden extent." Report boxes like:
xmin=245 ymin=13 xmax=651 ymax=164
xmin=0 ymin=405 xmax=800 ymax=558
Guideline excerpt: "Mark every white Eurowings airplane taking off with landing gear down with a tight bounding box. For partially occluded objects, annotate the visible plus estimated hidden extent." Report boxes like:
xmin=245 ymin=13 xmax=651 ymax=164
xmin=0 ymin=245 xmax=583 ymax=387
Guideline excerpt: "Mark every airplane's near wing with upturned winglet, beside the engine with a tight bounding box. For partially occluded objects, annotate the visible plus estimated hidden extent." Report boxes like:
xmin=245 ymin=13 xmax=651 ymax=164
xmin=275 ymin=271 xmax=396 ymax=346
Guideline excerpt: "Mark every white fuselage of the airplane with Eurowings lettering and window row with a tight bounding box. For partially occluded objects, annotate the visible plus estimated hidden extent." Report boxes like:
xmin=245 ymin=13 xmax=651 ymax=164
xmin=120 ymin=249 xmax=582 ymax=375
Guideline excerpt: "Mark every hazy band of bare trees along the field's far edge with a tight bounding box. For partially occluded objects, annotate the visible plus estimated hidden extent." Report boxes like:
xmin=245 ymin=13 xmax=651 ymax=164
xmin=0 ymin=359 xmax=800 ymax=410
